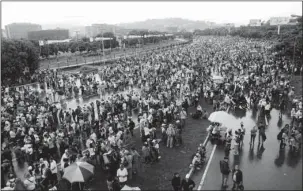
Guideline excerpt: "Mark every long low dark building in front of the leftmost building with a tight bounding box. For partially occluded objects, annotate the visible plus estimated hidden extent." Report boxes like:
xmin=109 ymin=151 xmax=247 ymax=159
xmin=28 ymin=29 xmax=69 ymax=40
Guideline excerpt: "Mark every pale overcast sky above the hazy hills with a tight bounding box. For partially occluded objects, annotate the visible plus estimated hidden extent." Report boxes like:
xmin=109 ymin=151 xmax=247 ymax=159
xmin=1 ymin=1 xmax=302 ymax=28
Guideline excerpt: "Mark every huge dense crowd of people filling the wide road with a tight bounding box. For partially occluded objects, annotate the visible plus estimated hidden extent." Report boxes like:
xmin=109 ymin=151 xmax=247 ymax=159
xmin=1 ymin=37 xmax=302 ymax=190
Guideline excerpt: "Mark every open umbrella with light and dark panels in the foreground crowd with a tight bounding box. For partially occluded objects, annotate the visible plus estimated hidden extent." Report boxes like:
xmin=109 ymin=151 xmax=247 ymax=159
xmin=63 ymin=162 xmax=94 ymax=183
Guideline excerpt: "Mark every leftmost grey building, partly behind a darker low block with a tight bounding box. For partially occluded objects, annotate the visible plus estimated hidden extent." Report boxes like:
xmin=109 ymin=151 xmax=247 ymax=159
xmin=5 ymin=23 xmax=42 ymax=39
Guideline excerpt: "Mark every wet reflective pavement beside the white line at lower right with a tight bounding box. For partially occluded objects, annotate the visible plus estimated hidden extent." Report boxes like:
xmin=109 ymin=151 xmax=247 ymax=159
xmin=192 ymin=109 xmax=302 ymax=190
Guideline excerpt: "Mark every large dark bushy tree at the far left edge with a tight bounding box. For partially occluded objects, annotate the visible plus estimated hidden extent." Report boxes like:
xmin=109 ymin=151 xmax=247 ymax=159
xmin=1 ymin=39 xmax=39 ymax=84
